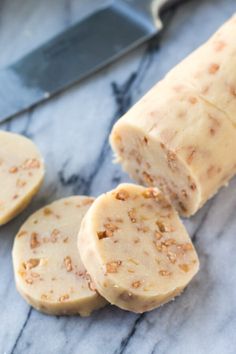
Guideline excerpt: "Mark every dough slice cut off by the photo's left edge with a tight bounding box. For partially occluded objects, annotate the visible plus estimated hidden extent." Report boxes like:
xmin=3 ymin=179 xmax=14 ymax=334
xmin=0 ymin=131 xmax=44 ymax=225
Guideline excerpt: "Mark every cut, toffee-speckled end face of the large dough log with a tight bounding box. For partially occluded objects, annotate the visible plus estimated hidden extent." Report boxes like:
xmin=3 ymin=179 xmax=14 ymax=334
xmin=109 ymin=119 xmax=202 ymax=217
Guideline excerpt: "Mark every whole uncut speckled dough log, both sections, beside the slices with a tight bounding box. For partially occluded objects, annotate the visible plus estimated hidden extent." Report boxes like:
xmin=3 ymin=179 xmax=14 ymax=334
xmin=110 ymin=16 xmax=236 ymax=216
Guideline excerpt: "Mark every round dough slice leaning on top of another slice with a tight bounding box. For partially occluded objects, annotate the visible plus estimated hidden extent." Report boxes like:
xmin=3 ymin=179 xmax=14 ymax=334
xmin=78 ymin=184 xmax=199 ymax=313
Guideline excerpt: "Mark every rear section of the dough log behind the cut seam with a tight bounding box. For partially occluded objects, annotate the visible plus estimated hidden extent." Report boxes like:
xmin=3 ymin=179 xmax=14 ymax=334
xmin=166 ymin=15 xmax=236 ymax=127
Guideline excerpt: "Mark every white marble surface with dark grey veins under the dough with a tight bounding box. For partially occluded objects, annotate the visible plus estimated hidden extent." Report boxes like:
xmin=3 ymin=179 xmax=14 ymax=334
xmin=0 ymin=0 xmax=236 ymax=354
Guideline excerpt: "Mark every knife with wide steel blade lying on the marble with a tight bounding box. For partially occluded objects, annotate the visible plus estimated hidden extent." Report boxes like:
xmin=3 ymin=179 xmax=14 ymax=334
xmin=0 ymin=0 xmax=184 ymax=122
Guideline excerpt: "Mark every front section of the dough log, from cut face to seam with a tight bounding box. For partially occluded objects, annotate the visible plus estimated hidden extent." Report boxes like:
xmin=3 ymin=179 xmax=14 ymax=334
xmin=110 ymin=79 xmax=236 ymax=216
